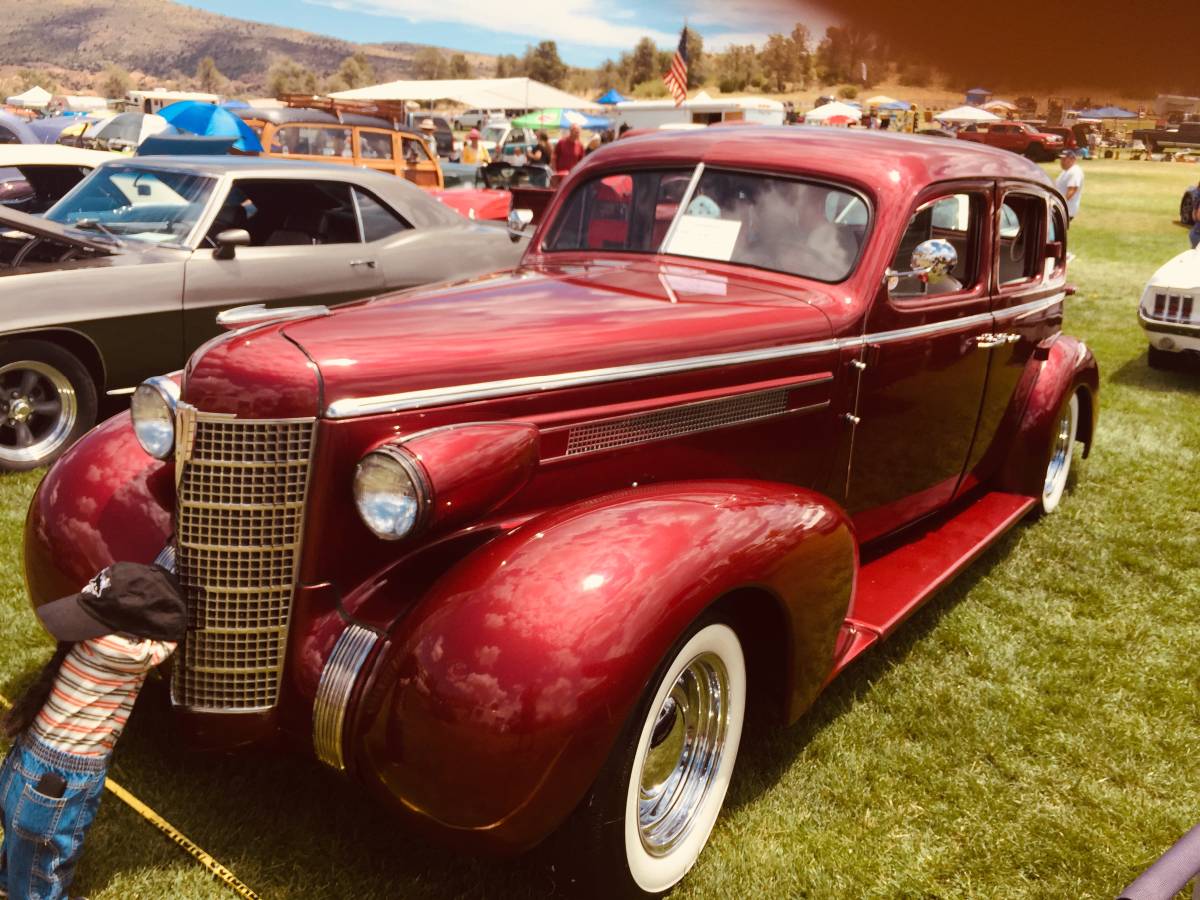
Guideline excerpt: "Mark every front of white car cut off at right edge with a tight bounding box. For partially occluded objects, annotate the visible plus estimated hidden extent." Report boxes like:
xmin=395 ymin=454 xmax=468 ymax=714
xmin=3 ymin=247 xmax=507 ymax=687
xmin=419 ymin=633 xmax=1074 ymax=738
xmin=1138 ymin=250 xmax=1200 ymax=368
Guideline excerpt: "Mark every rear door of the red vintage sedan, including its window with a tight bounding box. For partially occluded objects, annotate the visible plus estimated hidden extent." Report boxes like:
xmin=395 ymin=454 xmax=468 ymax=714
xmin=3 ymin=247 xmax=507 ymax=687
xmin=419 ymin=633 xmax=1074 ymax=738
xmin=959 ymin=182 xmax=1067 ymax=493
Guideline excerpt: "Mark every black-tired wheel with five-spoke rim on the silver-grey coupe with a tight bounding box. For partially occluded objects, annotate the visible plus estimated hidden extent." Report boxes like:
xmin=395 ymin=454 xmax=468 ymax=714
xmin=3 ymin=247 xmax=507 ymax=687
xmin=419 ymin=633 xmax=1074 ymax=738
xmin=0 ymin=340 xmax=96 ymax=472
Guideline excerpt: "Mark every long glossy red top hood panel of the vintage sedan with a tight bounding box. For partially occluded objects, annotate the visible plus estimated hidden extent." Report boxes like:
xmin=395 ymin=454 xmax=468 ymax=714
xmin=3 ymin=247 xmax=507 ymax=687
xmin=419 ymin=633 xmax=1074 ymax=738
xmin=281 ymin=263 xmax=830 ymax=408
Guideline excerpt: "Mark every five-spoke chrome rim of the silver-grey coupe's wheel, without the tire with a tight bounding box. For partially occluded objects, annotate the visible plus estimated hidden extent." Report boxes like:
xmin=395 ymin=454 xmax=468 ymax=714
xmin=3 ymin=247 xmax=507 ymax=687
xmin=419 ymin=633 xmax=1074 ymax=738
xmin=0 ymin=360 xmax=78 ymax=462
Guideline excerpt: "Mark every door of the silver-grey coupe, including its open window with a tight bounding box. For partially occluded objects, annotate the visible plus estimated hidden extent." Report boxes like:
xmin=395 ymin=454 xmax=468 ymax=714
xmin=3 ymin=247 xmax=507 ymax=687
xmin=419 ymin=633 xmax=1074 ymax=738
xmin=184 ymin=178 xmax=384 ymax=352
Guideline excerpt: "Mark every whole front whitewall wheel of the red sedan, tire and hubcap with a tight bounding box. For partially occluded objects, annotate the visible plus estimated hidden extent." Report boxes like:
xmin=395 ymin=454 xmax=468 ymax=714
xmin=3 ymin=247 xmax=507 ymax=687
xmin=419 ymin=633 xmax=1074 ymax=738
xmin=559 ymin=618 xmax=746 ymax=898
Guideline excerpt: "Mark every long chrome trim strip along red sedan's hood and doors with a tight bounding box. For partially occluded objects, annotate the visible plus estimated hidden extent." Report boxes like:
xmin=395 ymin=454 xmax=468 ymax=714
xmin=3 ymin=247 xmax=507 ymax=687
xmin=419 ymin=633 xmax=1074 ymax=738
xmin=325 ymin=293 xmax=1066 ymax=419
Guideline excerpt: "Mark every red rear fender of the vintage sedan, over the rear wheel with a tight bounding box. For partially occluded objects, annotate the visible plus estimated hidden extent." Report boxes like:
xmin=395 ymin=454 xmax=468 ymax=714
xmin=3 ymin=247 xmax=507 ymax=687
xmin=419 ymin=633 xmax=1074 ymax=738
xmin=1001 ymin=335 xmax=1100 ymax=497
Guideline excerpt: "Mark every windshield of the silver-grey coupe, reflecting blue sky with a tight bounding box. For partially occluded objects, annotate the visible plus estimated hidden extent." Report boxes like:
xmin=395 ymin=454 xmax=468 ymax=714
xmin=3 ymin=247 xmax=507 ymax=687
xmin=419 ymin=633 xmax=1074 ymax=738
xmin=46 ymin=166 xmax=216 ymax=244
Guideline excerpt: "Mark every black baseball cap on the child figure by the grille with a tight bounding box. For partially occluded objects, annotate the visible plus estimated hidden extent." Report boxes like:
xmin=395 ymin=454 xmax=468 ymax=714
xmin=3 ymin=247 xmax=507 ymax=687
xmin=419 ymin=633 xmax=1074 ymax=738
xmin=37 ymin=563 xmax=187 ymax=641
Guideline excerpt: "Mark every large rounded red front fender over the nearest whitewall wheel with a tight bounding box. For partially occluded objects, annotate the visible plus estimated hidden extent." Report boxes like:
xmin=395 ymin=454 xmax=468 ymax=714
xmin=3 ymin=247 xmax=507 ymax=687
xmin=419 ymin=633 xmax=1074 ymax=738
xmin=349 ymin=481 xmax=857 ymax=851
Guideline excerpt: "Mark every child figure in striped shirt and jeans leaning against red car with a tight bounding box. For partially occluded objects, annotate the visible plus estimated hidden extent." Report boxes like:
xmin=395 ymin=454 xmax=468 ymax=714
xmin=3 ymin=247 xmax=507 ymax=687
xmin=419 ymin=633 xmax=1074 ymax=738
xmin=0 ymin=563 xmax=187 ymax=900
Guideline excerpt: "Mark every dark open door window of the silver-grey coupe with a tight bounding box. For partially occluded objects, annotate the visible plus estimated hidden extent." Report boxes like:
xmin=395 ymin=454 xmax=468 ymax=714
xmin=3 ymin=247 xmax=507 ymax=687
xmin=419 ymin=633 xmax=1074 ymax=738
xmin=209 ymin=179 xmax=359 ymax=247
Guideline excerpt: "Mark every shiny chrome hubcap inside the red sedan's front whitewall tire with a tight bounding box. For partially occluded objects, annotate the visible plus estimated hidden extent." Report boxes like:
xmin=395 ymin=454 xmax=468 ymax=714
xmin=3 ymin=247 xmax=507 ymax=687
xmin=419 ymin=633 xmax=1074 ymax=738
xmin=637 ymin=653 xmax=730 ymax=856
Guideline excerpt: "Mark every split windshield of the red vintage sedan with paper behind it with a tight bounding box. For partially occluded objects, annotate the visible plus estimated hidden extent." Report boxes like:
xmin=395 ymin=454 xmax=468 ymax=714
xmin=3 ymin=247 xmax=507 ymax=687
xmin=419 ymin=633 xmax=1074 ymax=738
xmin=544 ymin=169 xmax=870 ymax=282
